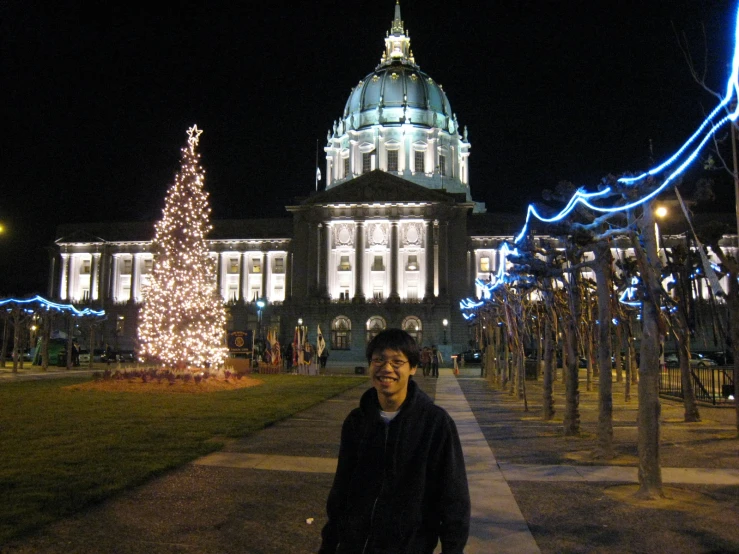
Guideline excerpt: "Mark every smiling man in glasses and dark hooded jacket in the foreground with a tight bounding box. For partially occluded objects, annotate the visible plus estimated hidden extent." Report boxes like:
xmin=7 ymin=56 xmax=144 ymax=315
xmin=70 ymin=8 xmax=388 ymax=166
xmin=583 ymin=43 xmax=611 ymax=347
xmin=319 ymin=329 xmax=470 ymax=554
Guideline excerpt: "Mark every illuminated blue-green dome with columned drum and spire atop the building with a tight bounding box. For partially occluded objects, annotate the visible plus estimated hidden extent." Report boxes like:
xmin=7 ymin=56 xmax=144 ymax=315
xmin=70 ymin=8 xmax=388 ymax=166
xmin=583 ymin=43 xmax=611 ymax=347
xmin=324 ymin=2 xmax=484 ymax=211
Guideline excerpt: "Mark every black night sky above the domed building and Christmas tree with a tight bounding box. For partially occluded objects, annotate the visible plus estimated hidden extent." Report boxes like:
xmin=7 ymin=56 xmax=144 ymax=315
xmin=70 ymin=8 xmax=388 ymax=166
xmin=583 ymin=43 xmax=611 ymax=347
xmin=0 ymin=0 xmax=735 ymax=296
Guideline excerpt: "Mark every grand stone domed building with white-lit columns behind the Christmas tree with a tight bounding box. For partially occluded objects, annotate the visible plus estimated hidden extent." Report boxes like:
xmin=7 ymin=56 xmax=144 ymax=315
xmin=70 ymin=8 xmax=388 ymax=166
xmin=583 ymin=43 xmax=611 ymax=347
xmin=49 ymin=4 xmax=518 ymax=365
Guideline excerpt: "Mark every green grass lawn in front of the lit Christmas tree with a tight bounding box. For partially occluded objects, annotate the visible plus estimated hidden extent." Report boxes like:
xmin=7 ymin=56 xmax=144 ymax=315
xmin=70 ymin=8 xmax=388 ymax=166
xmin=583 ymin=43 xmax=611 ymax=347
xmin=0 ymin=375 xmax=366 ymax=546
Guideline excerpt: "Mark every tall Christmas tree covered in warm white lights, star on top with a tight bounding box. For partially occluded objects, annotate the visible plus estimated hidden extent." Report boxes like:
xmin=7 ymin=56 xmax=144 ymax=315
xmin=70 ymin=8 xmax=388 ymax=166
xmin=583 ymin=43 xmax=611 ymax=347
xmin=138 ymin=125 xmax=227 ymax=369
